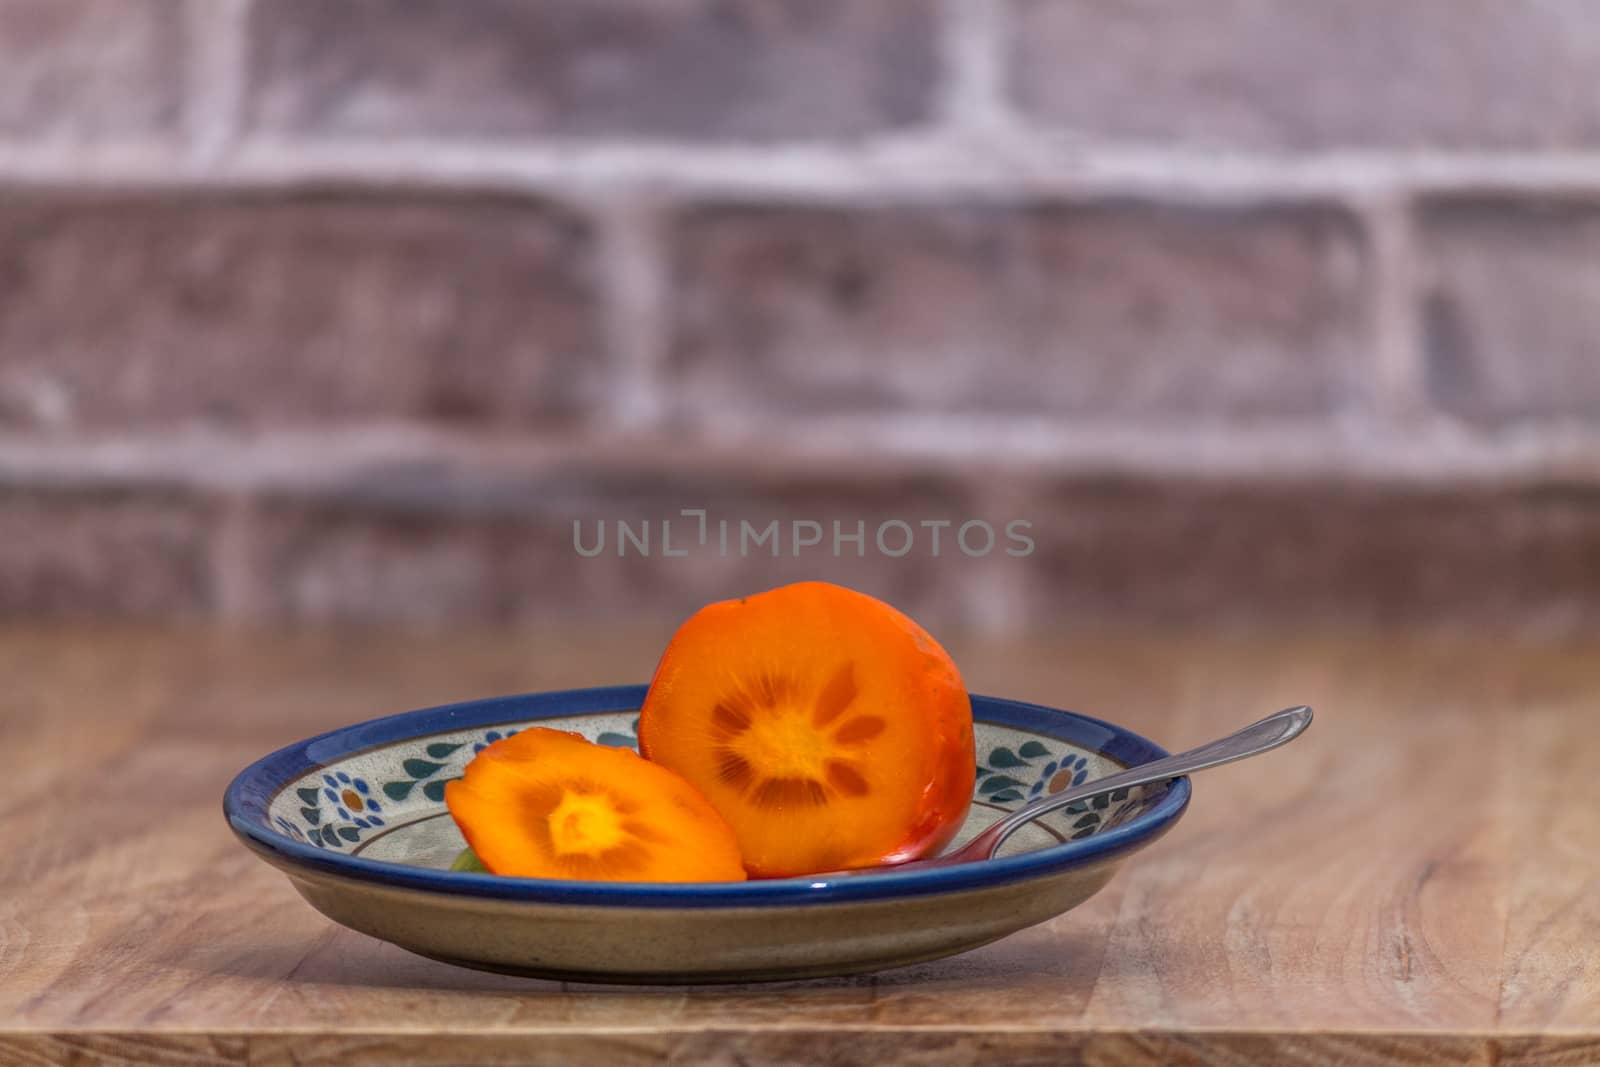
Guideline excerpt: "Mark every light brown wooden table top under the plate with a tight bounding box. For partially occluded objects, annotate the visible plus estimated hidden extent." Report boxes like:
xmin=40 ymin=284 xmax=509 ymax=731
xmin=0 ymin=632 xmax=1600 ymax=1065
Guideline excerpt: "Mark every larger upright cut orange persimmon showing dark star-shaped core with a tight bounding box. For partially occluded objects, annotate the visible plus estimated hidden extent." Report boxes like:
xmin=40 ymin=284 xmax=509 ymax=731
xmin=638 ymin=582 xmax=974 ymax=878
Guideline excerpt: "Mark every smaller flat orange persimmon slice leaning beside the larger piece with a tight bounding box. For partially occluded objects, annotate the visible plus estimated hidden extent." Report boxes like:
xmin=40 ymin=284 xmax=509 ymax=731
xmin=445 ymin=726 xmax=746 ymax=881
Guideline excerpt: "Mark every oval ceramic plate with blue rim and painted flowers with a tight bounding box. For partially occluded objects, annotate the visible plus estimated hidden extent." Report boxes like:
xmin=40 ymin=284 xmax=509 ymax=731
xmin=232 ymin=686 xmax=1189 ymax=982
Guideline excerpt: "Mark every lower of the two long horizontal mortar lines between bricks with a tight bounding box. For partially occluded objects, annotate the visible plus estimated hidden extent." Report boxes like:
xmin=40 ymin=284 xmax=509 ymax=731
xmin=0 ymin=416 xmax=1600 ymax=494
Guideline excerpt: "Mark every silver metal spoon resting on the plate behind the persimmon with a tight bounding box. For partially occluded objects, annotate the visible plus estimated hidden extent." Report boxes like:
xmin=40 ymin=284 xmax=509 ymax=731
xmin=813 ymin=705 xmax=1310 ymax=878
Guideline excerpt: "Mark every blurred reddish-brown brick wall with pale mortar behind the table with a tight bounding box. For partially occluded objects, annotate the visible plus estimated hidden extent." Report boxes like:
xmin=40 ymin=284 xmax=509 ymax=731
xmin=0 ymin=0 xmax=1600 ymax=630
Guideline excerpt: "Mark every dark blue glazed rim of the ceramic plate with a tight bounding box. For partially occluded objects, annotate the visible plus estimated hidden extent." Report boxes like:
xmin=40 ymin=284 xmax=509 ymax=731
xmin=232 ymin=685 xmax=1190 ymax=907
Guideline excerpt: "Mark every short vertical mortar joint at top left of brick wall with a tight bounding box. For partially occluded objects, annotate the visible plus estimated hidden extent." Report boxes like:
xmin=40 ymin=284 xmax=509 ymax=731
xmin=184 ymin=0 xmax=254 ymax=170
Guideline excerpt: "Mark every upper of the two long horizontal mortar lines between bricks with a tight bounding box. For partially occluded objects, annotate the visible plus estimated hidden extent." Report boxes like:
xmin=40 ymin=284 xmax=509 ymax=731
xmin=9 ymin=139 xmax=1600 ymax=202
